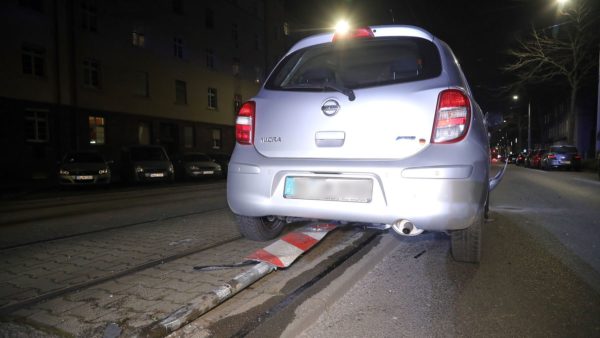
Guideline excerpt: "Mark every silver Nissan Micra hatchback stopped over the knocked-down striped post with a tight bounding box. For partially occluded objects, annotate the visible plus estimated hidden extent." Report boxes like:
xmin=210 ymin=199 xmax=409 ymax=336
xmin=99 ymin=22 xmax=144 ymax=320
xmin=227 ymin=26 xmax=501 ymax=262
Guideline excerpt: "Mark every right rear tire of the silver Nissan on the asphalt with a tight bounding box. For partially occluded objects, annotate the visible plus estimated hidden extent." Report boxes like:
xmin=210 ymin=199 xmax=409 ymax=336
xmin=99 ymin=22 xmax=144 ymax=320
xmin=450 ymin=212 xmax=484 ymax=263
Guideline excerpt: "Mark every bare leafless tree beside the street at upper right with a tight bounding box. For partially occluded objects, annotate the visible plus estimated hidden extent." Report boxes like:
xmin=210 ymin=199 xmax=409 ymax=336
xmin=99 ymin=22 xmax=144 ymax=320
xmin=504 ymin=1 xmax=597 ymax=143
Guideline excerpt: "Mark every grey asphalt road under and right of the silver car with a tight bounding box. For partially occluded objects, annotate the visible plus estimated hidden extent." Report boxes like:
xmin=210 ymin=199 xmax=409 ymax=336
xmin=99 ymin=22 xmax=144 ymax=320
xmin=284 ymin=166 xmax=600 ymax=337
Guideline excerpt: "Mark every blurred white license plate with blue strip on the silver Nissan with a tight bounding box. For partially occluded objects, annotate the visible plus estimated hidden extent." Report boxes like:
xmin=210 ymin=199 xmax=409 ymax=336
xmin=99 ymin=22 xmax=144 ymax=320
xmin=283 ymin=176 xmax=373 ymax=203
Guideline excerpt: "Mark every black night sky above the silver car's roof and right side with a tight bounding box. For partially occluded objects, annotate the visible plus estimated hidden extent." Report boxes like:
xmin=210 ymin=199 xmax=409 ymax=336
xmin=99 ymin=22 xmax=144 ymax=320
xmin=286 ymin=0 xmax=573 ymax=111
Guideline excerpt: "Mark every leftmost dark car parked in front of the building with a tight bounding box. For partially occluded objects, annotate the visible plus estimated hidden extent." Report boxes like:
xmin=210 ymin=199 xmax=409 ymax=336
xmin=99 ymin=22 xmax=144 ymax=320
xmin=58 ymin=151 xmax=112 ymax=186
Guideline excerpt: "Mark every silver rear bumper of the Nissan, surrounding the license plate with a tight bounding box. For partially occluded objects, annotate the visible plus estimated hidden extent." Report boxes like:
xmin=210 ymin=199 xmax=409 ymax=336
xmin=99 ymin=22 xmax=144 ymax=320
xmin=227 ymin=145 xmax=489 ymax=231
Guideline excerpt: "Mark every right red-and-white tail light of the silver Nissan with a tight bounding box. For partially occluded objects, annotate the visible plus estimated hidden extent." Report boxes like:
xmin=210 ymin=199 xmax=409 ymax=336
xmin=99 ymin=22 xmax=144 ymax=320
xmin=431 ymin=89 xmax=471 ymax=143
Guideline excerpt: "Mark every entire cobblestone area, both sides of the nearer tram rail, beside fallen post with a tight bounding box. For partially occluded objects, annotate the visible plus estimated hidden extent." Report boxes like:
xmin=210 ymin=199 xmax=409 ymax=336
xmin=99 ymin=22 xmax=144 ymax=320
xmin=0 ymin=195 xmax=274 ymax=337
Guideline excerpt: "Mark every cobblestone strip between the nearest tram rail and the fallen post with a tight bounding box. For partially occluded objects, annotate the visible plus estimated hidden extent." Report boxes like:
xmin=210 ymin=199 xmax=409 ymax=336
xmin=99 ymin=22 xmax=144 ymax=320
xmin=0 ymin=235 xmax=268 ymax=337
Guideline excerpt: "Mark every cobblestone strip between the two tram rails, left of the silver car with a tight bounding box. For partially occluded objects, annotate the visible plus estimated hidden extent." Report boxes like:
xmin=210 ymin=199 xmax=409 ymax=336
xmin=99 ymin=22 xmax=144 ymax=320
xmin=0 ymin=210 xmax=240 ymax=309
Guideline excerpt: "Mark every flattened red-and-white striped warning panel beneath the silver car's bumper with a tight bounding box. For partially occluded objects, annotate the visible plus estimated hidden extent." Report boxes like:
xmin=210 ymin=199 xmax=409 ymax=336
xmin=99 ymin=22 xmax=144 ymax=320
xmin=246 ymin=223 xmax=336 ymax=268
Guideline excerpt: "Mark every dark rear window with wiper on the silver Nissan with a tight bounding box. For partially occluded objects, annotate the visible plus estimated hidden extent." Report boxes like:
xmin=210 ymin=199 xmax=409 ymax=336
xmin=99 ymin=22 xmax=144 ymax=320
xmin=265 ymin=37 xmax=441 ymax=91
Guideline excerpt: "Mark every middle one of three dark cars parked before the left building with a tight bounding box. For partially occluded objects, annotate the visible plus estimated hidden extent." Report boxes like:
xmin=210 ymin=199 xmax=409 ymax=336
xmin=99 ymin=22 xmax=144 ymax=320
xmin=121 ymin=145 xmax=175 ymax=183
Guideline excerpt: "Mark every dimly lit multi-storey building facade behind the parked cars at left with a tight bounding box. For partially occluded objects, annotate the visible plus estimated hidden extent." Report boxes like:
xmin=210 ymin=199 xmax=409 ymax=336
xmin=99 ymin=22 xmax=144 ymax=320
xmin=0 ymin=0 xmax=285 ymax=181
